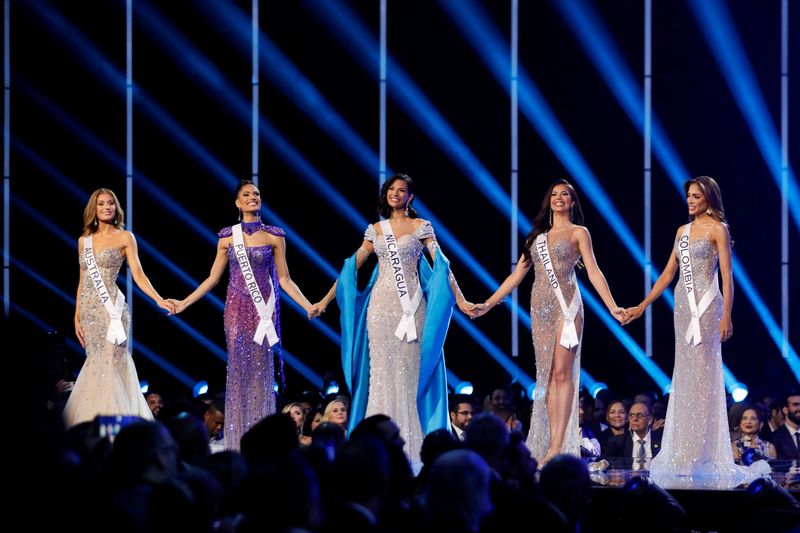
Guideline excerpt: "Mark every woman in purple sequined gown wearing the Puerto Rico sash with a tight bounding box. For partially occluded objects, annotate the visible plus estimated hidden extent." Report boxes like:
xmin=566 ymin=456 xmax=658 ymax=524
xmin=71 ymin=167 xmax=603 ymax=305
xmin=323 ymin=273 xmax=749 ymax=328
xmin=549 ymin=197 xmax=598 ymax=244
xmin=175 ymin=180 xmax=314 ymax=450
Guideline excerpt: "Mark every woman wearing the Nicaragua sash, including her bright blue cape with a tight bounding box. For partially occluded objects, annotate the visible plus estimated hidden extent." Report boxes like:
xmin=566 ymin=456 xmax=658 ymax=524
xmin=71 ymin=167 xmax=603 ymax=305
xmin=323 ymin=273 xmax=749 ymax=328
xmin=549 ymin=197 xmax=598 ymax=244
xmin=318 ymin=174 xmax=472 ymax=462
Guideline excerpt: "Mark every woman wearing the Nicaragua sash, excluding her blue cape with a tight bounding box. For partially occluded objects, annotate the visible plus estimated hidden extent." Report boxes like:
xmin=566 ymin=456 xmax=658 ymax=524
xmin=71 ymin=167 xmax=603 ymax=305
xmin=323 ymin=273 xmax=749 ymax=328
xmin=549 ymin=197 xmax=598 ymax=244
xmin=318 ymin=174 xmax=472 ymax=462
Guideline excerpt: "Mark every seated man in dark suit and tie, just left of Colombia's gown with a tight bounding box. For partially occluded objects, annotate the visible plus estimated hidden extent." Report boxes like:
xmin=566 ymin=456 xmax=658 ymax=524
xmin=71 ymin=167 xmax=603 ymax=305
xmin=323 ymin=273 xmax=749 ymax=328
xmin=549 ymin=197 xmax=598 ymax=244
xmin=603 ymin=402 xmax=664 ymax=470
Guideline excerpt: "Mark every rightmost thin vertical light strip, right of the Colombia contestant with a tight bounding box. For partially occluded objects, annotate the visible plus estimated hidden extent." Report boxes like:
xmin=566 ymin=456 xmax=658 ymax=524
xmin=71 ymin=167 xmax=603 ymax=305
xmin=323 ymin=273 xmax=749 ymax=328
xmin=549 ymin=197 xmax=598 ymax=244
xmin=781 ymin=0 xmax=789 ymax=359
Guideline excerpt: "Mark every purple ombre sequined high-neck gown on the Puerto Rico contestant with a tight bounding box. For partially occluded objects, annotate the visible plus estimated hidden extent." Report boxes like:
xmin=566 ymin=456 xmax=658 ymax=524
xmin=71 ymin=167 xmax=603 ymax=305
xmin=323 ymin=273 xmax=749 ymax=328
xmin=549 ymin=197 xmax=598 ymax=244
xmin=219 ymin=221 xmax=286 ymax=450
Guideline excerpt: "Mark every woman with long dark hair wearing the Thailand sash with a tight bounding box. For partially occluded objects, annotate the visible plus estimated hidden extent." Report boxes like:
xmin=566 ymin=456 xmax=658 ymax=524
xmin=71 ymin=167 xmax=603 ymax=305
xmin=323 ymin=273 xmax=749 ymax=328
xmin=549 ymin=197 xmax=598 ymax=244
xmin=472 ymin=180 xmax=625 ymax=464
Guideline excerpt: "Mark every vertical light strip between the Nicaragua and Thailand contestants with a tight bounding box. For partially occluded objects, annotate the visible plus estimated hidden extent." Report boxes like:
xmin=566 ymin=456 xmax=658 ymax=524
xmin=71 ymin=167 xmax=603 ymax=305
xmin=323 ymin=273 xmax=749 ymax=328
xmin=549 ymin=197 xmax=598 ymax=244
xmin=510 ymin=0 xmax=519 ymax=357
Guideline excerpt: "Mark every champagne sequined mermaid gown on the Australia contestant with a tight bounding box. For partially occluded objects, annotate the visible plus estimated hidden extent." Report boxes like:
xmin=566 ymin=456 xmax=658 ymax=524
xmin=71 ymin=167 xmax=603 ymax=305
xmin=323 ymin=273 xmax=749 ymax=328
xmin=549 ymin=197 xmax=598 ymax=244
xmin=64 ymin=248 xmax=153 ymax=427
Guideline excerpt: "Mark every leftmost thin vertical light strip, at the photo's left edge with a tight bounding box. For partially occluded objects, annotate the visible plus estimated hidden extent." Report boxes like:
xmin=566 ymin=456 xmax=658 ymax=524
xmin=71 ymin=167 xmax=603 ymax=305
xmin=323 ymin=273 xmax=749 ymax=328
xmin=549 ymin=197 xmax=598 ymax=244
xmin=3 ymin=0 xmax=11 ymax=319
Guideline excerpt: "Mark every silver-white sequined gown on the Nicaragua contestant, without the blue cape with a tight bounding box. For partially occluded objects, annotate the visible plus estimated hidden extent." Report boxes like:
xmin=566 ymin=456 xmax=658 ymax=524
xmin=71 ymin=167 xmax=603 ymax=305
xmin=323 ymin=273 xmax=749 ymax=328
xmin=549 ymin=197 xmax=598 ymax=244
xmin=364 ymin=222 xmax=434 ymax=462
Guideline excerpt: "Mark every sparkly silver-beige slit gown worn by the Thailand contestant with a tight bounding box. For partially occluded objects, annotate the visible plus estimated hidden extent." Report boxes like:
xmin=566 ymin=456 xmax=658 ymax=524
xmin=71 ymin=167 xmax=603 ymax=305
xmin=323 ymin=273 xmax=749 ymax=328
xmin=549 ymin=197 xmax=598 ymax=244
xmin=525 ymin=236 xmax=583 ymax=459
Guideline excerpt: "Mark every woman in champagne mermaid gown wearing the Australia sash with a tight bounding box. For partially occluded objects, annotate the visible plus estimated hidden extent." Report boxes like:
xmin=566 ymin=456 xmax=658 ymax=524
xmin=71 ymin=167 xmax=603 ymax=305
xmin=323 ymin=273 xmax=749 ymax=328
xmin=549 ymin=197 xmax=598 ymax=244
xmin=64 ymin=189 xmax=173 ymax=427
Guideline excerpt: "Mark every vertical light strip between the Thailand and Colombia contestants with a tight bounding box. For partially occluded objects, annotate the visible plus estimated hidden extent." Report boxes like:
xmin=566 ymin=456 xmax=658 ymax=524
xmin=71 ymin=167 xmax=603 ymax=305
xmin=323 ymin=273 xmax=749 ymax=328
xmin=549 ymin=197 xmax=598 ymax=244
xmin=643 ymin=0 xmax=653 ymax=357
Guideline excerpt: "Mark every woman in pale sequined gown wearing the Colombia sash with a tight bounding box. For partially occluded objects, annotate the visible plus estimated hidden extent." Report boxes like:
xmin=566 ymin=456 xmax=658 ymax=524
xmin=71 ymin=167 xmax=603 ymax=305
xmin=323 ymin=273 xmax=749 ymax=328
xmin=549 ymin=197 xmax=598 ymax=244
xmin=628 ymin=176 xmax=768 ymax=488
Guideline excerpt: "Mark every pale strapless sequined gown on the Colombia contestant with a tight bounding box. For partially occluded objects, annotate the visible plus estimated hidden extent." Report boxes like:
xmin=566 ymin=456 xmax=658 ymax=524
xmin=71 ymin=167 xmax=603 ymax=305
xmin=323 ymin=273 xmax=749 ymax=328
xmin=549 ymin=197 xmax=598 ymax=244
xmin=650 ymin=229 xmax=756 ymax=488
